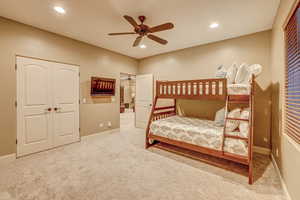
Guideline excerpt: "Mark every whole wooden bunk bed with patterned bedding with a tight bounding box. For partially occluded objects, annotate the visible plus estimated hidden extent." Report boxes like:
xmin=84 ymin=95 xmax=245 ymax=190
xmin=146 ymin=75 xmax=255 ymax=184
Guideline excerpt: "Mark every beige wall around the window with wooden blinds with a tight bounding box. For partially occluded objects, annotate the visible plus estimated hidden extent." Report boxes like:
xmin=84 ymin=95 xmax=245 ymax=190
xmin=271 ymin=0 xmax=300 ymax=200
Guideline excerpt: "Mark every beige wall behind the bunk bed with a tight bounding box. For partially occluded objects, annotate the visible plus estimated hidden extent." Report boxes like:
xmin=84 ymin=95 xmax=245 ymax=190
xmin=139 ymin=31 xmax=271 ymax=148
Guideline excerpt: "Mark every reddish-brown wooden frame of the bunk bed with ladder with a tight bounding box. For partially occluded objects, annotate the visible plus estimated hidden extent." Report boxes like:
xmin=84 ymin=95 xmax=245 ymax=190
xmin=145 ymin=76 xmax=255 ymax=184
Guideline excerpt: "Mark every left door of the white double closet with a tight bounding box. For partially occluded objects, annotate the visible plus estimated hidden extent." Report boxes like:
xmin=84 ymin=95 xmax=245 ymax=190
xmin=17 ymin=57 xmax=53 ymax=156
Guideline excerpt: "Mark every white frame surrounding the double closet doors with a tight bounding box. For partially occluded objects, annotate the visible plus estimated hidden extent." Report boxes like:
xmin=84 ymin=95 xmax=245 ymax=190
xmin=14 ymin=54 xmax=81 ymax=158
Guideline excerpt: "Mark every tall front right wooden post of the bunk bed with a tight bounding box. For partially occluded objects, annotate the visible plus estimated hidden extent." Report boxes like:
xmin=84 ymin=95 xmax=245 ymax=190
xmin=248 ymin=75 xmax=255 ymax=185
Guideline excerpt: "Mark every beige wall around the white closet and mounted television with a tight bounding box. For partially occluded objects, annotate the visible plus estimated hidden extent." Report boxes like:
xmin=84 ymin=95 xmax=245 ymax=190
xmin=0 ymin=18 xmax=138 ymax=156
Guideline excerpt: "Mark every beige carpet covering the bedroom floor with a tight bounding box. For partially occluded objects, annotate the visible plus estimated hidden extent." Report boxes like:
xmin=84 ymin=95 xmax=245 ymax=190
xmin=0 ymin=113 xmax=285 ymax=200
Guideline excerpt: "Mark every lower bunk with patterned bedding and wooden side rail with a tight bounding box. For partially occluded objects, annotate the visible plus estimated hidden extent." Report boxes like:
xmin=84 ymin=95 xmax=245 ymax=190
xmin=146 ymin=113 xmax=253 ymax=184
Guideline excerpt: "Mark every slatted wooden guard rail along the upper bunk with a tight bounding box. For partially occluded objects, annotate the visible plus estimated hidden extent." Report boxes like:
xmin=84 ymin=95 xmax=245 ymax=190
xmin=156 ymin=78 xmax=227 ymax=100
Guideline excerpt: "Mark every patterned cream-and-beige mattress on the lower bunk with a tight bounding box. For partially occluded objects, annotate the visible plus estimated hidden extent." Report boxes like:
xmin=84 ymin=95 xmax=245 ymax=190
xmin=150 ymin=115 xmax=248 ymax=156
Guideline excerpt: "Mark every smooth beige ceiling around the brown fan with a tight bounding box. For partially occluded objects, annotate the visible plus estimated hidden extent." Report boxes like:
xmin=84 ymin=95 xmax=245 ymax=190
xmin=0 ymin=0 xmax=280 ymax=58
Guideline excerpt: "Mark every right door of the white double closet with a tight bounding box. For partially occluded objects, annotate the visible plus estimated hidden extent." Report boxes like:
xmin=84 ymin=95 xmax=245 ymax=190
xmin=52 ymin=63 xmax=79 ymax=146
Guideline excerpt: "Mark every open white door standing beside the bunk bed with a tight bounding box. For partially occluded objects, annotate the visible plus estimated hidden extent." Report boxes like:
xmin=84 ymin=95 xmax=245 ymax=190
xmin=135 ymin=74 xmax=153 ymax=128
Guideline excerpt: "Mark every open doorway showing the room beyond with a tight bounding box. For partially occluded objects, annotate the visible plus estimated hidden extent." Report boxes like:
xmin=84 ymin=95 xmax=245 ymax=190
xmin=120 ymin=73 xmax=136 ymax=128
